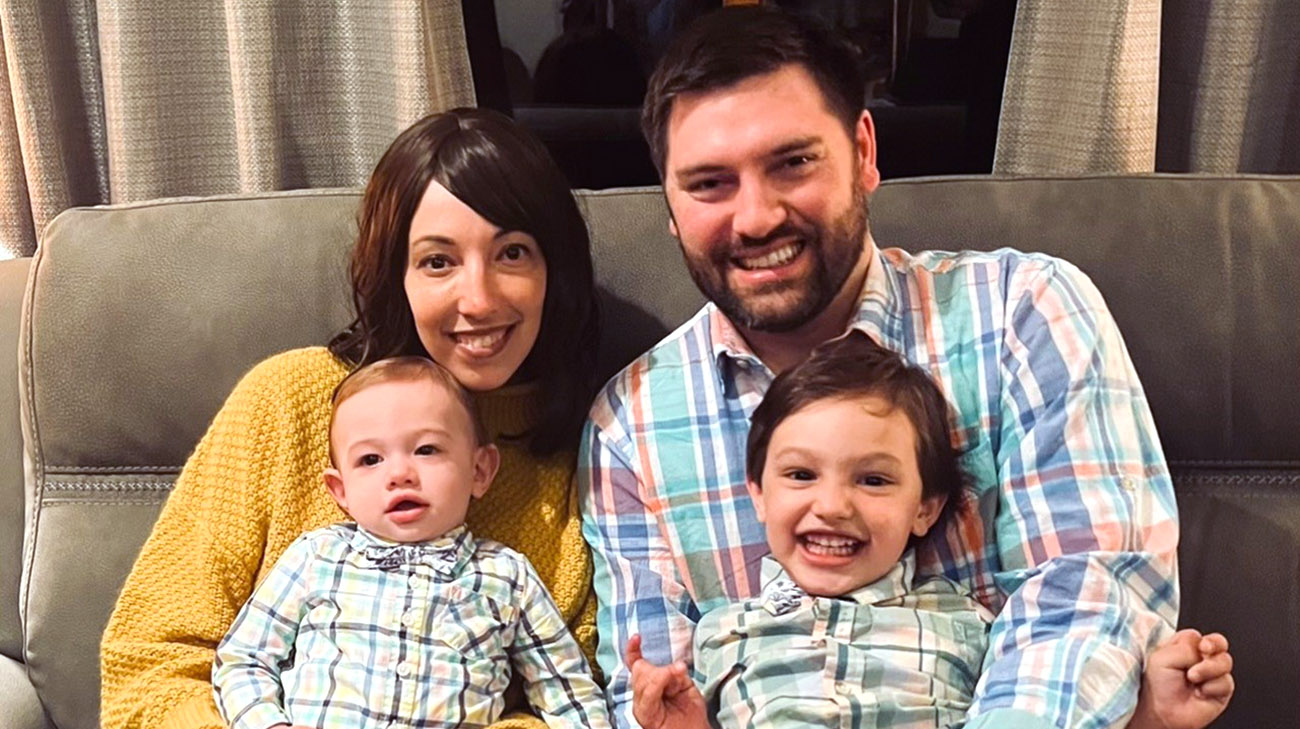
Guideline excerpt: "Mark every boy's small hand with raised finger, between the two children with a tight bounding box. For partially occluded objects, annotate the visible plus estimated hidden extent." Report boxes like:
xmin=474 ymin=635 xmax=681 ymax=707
xmin=628 ymin=635 xmax=709 ymax=729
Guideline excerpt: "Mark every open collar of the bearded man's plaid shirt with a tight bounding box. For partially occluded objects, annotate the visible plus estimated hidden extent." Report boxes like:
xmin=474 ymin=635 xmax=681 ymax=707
xmin=709 ymin=234 xmax=905 ymax=377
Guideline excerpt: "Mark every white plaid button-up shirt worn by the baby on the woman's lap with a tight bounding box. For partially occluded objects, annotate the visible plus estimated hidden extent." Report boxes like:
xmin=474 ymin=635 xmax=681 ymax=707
xmin=212 ymin=524 xmax=608 ymax=729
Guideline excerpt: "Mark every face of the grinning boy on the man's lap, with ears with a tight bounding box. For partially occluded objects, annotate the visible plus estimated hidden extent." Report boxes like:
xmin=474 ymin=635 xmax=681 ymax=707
xmin=749 ymin=396 xmax=943 ymax=596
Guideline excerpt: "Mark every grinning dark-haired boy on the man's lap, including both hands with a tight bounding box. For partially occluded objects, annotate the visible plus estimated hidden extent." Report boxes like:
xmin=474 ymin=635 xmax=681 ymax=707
xmin=628 ymin=331 xmax=1232 ymax=729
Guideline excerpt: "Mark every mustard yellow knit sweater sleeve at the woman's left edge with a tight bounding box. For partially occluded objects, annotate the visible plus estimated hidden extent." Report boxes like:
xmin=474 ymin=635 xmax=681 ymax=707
xmin=100 ymin=350 xmax=333 ymax=729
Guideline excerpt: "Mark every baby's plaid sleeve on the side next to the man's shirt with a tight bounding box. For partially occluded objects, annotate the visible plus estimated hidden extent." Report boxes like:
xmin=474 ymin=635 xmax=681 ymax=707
xmin=510 ymin=555 xmax=610 ymax=729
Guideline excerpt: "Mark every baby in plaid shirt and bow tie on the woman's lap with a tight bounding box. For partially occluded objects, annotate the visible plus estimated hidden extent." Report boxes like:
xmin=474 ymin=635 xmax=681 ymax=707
xmin=212 ymin=357 xmax=608 ymax=729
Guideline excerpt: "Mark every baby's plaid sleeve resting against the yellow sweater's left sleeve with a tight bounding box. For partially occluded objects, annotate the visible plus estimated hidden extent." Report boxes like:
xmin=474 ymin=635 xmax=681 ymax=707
xmin=212 ymin=538 xmax=315 ymax=729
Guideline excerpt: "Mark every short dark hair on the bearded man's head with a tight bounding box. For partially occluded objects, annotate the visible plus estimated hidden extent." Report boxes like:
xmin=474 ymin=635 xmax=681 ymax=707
xmin=641 ymin=6 xmax=866 ymax=177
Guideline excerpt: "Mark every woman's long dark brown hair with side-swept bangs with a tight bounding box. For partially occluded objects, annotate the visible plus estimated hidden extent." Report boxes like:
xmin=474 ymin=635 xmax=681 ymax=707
xmin=329 ymin=109 xmax=599 ymax=454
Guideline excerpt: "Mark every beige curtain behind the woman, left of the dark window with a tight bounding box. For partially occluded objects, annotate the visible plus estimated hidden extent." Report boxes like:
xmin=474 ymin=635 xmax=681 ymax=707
xmin=0 ymin=0 xmax=475 ymax=255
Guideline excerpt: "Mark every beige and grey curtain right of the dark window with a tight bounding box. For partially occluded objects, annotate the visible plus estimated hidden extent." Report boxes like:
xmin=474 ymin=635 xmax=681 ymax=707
xmin=993 ymin=0 xmax=1300 ymax=174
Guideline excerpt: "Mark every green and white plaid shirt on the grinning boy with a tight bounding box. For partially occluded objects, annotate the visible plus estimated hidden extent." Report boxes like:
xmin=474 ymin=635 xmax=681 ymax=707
xmin=696 ymin=551 xmax=993 ymax=729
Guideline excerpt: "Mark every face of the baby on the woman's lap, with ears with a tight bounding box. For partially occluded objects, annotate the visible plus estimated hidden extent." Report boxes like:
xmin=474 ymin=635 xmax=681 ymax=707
xmin=325 ymin=378 xmax=498 ymax=542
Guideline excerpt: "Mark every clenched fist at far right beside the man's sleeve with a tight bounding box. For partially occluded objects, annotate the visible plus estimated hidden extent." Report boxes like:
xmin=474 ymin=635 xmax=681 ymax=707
xmin=1128 ymin=629 xmax=1235 ymax=729
